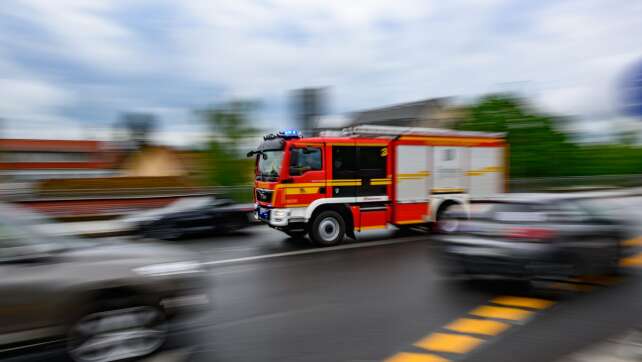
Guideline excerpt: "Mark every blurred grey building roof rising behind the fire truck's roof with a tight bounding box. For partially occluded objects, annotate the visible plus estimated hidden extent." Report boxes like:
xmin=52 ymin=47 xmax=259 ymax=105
xmin=350 ymin=98 xmax=463 ymax=128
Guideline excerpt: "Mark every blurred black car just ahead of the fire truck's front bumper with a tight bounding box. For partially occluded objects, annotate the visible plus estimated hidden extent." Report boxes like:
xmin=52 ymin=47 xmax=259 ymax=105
xmin=121 ymin=196 xmax=254 ymax=240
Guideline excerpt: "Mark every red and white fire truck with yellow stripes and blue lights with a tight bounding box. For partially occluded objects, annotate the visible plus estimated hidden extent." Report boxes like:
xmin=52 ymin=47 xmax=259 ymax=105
xmin=248 ymin=126 xmax=506 ymax=246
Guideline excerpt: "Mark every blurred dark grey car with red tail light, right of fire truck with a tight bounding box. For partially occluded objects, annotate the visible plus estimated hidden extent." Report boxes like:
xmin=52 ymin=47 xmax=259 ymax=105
xmin=440 ymin=194 xmax=631 ymax=279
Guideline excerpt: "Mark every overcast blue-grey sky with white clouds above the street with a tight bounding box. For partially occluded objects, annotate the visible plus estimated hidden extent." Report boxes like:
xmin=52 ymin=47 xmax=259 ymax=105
xmin=0 ymin=0 xmax=642 ymax=144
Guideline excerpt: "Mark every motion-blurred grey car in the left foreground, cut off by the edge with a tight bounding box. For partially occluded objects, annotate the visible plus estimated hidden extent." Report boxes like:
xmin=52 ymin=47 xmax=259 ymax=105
xmin=0 ymin=204 xmax=210 ymax=362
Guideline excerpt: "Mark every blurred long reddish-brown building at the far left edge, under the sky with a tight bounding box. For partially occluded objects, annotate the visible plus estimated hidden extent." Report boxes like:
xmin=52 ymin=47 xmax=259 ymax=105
xmin=0 ymin=139 xmax=114 ymax=180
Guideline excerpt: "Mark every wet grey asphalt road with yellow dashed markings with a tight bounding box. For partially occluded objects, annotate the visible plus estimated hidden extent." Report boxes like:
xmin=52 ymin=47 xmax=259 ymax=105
xmin=7 ymin=198 xmax=642 ymax=362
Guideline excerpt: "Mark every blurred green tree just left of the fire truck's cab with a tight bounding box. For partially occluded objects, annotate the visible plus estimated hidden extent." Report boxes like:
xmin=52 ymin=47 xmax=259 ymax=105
xmin=197 ymin=100 xmax=258 ymax=201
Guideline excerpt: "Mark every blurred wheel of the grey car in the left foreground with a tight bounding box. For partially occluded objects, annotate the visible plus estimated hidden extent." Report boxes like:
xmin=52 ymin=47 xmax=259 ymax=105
xmin=67 ymin=306 xmax=167 ymax=362
